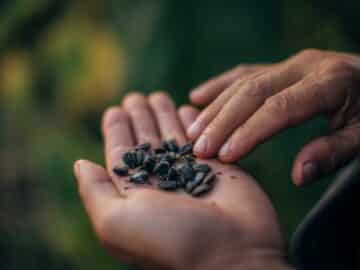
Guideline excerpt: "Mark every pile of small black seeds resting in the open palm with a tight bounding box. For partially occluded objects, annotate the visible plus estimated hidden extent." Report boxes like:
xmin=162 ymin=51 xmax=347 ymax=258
xmin=113 ymin=140 xmax=216 ymax=196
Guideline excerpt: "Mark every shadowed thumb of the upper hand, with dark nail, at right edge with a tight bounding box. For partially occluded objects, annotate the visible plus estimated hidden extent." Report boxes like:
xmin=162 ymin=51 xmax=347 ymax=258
xmin=292 ymin=125 xmax=360 ymax=186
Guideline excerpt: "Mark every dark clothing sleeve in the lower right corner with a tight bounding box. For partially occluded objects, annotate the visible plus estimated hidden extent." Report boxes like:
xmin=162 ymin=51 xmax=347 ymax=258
xmin=291 ymin=157 xmax=360 ymax=270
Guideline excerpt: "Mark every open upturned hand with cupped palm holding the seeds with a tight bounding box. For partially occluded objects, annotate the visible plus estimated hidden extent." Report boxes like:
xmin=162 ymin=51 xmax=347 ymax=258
xmin=74 ymin=93 xmax=291 ymax=270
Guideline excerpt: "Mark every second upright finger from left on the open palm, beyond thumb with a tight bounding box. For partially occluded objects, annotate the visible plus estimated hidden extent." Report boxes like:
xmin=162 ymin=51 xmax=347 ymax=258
xmin=123 ymin=93 xmax=160 ymax=147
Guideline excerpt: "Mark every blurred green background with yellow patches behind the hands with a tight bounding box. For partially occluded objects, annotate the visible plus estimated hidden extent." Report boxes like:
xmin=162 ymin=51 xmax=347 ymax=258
xmin=0 ymin=0 xmax=360 ymax=270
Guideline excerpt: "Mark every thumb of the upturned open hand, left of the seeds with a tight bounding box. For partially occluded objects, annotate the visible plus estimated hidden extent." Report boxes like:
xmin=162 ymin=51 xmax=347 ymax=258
xmin=74 ymin=160 xmax=119 ymax=222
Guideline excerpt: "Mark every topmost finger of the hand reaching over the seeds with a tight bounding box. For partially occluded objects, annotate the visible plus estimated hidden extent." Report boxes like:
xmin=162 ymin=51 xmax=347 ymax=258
xmin=190 ymin=65 xmax=266 ymax=105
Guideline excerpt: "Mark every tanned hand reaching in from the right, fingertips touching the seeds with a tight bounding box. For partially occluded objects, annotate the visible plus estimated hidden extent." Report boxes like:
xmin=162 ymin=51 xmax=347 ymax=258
xmin=187 ymin=49 xmax=360 ymax=185
